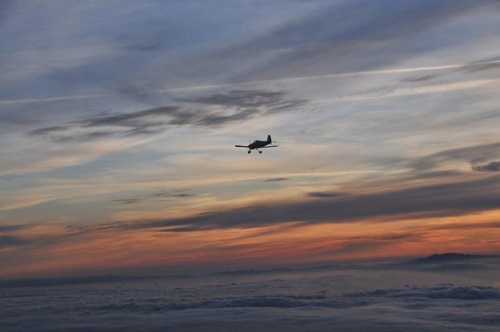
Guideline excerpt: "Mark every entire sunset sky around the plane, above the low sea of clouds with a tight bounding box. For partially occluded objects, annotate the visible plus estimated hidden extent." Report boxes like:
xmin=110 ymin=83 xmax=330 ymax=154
xmin=0 ymin=0 xmax=500 ymax=278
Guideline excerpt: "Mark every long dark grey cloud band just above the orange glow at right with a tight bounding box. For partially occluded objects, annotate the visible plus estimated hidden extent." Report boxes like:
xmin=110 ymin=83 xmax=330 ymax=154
xmin=124 ymin=176 xmax=500 ymax=232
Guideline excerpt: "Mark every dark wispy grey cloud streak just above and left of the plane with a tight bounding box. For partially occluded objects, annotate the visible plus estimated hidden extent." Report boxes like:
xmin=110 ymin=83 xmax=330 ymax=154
xmin=29 ymin=90 xmax=307 ymax=142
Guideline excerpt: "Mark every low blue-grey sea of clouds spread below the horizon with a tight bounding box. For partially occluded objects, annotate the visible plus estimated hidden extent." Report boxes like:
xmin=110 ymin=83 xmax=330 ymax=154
xmin=0 ymin=270 xmax=500 ymax=332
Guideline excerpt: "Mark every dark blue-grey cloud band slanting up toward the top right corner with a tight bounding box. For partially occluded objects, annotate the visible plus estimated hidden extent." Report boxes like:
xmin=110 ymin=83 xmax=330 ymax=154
xmin=208 ymin=0 xmax=494 ymax=82
